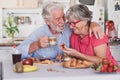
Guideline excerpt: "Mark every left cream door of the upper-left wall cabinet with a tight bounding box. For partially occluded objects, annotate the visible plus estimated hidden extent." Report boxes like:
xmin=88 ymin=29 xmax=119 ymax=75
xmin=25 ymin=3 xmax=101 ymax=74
xmin=0 ymin=0 xmax=19 ymax=8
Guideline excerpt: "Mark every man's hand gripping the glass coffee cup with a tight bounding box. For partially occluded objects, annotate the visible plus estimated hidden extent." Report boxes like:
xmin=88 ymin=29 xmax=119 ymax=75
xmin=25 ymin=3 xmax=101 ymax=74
xmin=38 ymin=36 xmax=49 ymax=48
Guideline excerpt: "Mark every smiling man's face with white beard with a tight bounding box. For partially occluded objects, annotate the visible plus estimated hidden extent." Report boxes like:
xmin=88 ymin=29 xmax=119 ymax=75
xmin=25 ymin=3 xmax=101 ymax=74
xmin=50 ymin=9 xmax=65 ymax=32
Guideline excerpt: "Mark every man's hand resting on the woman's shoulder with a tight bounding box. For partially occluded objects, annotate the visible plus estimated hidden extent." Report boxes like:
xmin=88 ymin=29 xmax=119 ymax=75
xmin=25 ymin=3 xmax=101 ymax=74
xmin=89 ymin=22 xmax=104 ymax=39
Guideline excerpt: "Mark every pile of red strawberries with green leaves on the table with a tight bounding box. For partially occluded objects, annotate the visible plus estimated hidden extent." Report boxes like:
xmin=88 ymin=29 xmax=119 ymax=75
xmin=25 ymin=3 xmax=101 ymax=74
xmin=92 ymin=58 xmax=118 ymax=73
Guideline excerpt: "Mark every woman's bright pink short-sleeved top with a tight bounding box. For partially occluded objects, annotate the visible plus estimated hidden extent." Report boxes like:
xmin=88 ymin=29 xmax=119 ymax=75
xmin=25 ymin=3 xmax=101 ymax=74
xmin=70 ymin=33 xmax=118 ymax=65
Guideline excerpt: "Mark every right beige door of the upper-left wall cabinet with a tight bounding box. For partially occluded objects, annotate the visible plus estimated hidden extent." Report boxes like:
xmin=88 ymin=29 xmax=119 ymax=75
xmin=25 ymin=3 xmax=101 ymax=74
xmin=19 ymin=0 xmax=38 ymax=8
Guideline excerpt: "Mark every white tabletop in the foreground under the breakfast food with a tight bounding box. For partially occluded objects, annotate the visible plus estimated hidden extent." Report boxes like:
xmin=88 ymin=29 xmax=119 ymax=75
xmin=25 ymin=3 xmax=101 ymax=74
xmin=3 ymin=60 xmax=120 ymax=80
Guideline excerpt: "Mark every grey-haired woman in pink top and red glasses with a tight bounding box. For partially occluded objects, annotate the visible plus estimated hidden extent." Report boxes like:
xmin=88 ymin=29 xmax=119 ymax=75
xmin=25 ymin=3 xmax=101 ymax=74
xmin=63 ymin=5 xmax=117 ymax=64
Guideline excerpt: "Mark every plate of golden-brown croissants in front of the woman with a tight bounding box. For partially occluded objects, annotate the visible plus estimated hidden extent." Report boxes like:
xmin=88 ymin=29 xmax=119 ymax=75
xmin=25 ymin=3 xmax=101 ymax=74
xmin=63 ymin=58 xmax=93 ymax=68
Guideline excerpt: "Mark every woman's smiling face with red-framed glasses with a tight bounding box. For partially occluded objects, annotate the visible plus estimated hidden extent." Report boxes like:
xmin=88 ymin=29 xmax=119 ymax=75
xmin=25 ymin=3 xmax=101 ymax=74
xmin=68 ymin=20 xmax=87 ymax=35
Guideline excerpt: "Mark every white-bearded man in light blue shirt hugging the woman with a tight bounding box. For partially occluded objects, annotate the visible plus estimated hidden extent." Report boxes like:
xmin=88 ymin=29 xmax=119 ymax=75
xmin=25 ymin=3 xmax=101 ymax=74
xmin=17 ymin=2 xmax=103 ymax=59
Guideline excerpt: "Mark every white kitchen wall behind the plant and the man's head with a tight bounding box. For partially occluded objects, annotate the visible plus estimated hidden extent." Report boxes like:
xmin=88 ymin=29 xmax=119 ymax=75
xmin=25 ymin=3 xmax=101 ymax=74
xmin=0 ymin=0 xmax=70 ymax=37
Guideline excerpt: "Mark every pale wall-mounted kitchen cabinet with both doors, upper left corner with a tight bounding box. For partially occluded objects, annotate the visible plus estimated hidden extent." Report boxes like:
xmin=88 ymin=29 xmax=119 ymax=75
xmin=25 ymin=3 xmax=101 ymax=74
xmin=0 ymin=0 xmax=38 ymax=8
